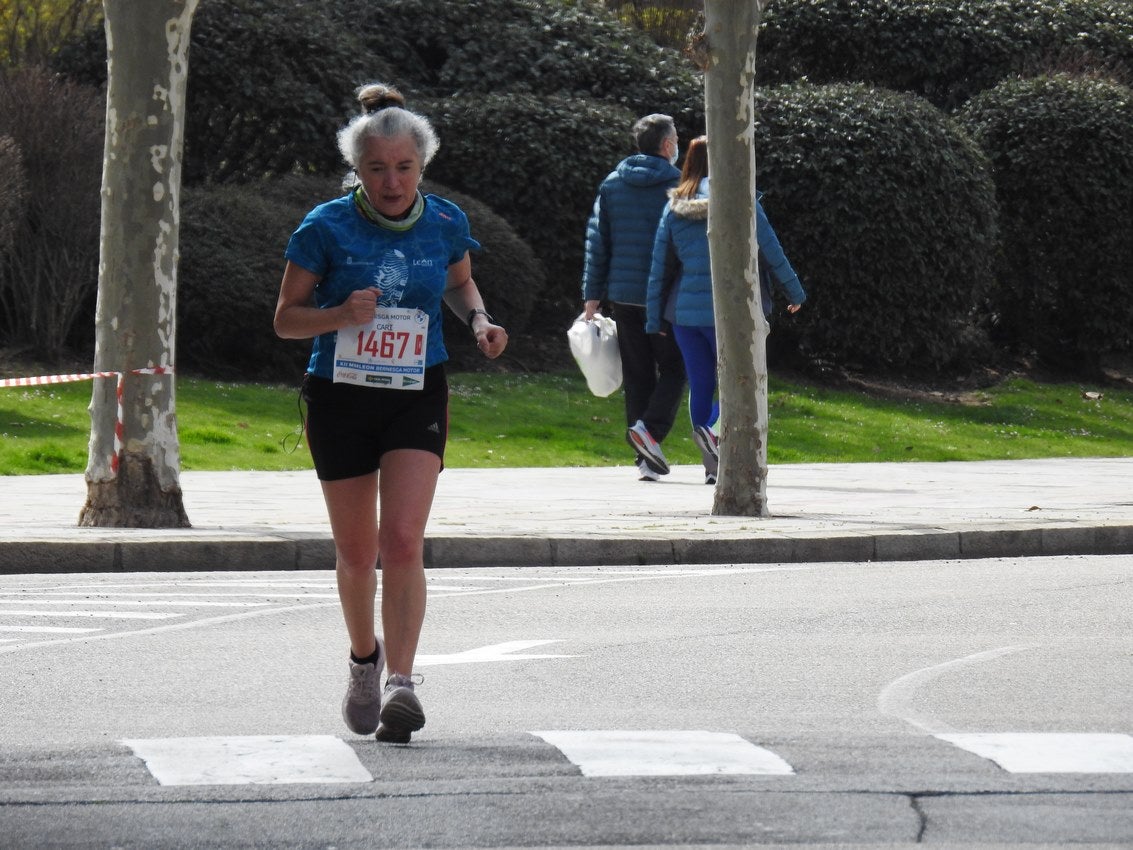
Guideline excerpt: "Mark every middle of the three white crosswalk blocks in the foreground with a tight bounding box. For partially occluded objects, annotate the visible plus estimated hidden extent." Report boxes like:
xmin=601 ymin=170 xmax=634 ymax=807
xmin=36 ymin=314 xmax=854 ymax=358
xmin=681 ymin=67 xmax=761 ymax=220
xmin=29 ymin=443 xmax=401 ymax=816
xmin=531 ymin=730 xmax=794 ymax=776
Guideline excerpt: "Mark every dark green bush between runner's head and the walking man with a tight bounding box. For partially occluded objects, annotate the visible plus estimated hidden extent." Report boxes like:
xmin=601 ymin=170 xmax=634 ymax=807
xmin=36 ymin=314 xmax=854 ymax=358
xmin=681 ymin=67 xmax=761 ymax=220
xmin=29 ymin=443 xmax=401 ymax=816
xmin=418 ymin=94 xmax=636 ymax=328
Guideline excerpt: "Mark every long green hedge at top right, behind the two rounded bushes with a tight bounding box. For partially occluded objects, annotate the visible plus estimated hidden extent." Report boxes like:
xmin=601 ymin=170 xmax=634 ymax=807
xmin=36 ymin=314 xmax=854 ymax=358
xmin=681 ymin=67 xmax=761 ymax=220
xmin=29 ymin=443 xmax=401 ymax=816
xmin=757 ymin=0 xmax=1133 ymax=110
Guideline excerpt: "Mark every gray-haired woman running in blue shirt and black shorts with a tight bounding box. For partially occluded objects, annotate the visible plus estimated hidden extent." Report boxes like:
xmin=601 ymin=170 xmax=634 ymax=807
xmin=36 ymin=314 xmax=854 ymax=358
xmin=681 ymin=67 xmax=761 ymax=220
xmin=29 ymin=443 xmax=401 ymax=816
xmin=275 ymin=86 xmax=508 ymax=742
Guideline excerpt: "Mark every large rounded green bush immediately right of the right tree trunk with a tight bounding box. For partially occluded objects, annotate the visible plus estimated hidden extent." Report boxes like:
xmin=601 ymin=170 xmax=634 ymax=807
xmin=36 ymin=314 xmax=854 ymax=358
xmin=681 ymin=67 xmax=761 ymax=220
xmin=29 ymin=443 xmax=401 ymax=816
xmin=756 ymin=85 xmax=997 ymax=373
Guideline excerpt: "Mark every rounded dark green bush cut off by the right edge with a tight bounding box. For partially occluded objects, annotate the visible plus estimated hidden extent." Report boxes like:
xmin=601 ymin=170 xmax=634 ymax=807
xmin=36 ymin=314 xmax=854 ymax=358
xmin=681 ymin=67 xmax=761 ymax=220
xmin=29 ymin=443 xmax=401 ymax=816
xmin=957 ymin=75 xmax=1133 ymax=369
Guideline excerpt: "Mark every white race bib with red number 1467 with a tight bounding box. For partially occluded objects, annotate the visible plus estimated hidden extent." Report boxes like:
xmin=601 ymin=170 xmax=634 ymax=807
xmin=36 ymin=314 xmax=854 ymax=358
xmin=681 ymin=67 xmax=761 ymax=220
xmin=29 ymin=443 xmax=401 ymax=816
xmin=334 ymin=307 xmax=428 ymax=390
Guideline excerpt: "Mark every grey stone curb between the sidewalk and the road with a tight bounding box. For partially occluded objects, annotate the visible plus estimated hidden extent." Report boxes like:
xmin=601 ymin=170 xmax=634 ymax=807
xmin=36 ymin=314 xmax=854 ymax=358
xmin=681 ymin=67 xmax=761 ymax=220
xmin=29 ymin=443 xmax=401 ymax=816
xmin=0 ymin=525 xmax=1133 ymax=575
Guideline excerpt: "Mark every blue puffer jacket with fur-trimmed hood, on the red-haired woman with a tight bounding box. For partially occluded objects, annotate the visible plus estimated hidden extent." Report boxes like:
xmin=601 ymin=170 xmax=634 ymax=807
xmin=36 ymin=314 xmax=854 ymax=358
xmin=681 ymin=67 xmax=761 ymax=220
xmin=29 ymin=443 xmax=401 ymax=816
xmin=646 ymin=178 xmax=807 ymax=333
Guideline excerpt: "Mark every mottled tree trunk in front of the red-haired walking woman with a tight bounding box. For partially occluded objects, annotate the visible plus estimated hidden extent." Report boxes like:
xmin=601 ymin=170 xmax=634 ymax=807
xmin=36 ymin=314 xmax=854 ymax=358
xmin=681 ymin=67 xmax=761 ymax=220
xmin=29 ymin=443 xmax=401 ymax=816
xmin=700 ymin=0 xmax=769 ymax=517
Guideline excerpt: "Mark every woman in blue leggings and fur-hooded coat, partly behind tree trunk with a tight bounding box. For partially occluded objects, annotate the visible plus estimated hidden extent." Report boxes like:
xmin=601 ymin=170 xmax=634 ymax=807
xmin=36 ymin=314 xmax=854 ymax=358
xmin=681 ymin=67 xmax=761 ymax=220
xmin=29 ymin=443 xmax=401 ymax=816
xmin=646 ymin=136 xmax=807 ymax=484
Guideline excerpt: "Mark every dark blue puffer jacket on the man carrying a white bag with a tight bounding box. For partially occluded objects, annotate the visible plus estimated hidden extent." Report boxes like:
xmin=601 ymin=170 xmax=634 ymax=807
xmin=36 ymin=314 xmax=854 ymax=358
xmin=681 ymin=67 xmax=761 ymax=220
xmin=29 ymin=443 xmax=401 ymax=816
xmin=582 ymin=153 xmax=681 ymax=306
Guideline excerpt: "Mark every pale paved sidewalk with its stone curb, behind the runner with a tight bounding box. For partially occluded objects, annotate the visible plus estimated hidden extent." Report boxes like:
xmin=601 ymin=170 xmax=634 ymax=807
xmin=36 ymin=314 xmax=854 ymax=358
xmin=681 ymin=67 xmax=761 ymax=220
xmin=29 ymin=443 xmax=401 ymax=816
xmin=0 ymin=458 xmax=1133 ymax=573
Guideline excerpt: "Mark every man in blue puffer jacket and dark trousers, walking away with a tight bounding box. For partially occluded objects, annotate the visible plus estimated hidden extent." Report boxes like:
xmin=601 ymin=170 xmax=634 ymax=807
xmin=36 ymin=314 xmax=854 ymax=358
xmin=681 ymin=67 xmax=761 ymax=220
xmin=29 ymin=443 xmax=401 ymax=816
xmin=582 ymin=114 xmax=684 ymax=481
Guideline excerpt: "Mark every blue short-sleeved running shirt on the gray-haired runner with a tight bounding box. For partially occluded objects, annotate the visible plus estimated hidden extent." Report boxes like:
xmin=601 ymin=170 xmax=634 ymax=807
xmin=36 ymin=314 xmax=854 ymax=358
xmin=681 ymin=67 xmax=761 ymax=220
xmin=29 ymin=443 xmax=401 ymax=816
xmin=284 ymin=195 xmax=480 ymax=379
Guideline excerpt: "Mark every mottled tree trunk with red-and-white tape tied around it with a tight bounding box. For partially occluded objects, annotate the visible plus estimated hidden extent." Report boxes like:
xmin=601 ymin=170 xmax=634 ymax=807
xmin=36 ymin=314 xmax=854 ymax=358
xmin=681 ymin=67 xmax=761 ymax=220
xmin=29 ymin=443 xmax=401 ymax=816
xmin=79 ymin=0 xmax=197 ymax=528
